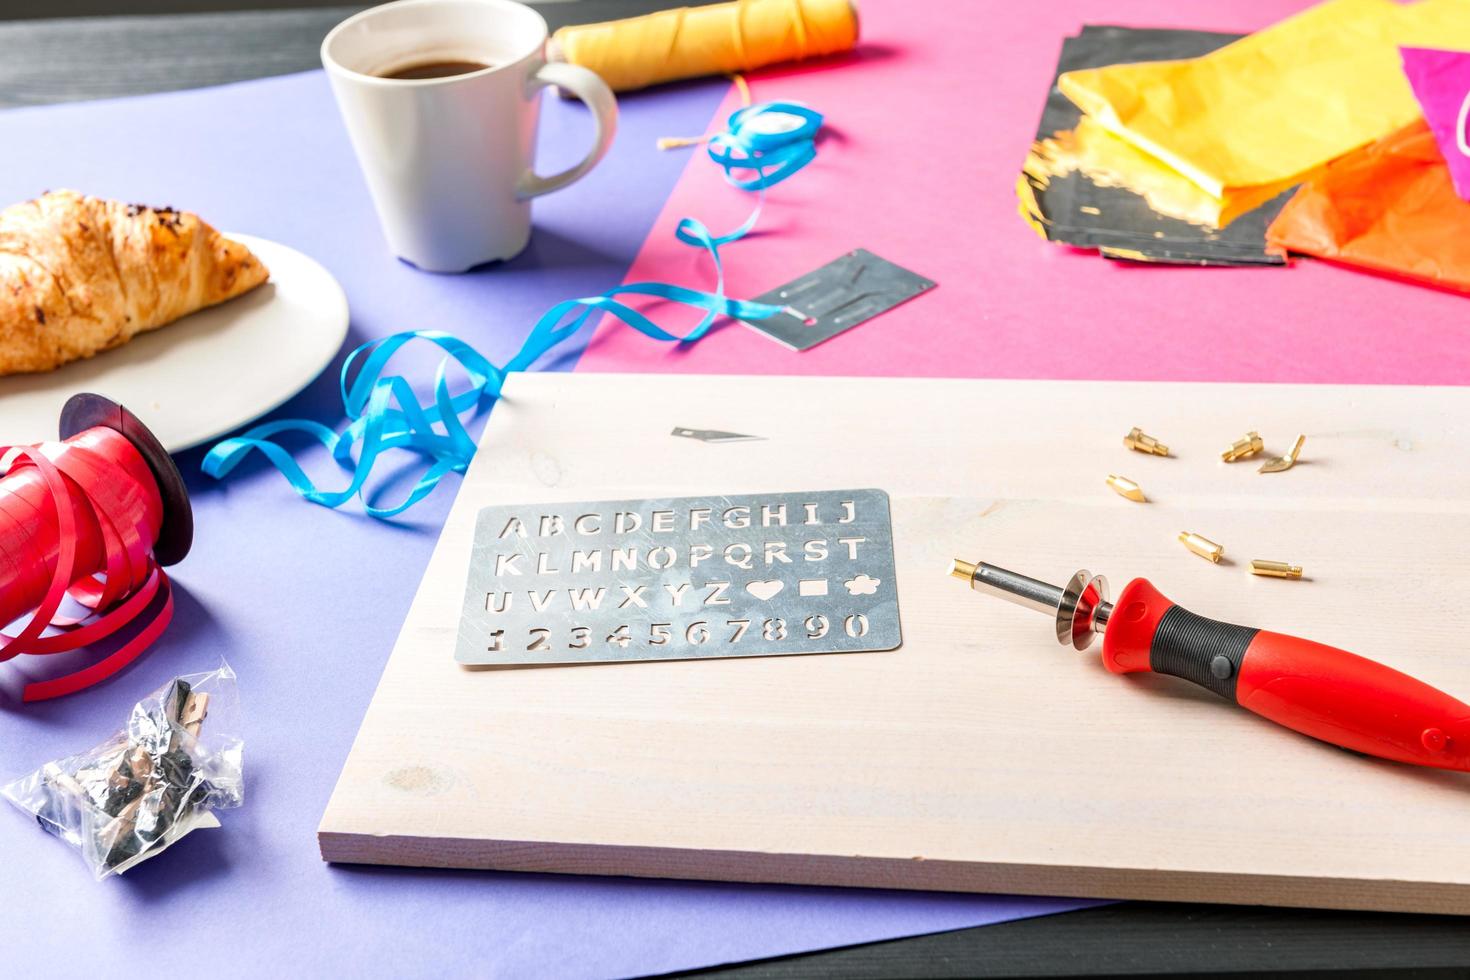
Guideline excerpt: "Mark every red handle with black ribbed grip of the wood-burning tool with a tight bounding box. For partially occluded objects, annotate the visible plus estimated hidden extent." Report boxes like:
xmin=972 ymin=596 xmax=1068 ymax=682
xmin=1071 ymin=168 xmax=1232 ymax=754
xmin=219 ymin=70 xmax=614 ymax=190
xmin=1103 ymin=579 xmax=1470 ymax=771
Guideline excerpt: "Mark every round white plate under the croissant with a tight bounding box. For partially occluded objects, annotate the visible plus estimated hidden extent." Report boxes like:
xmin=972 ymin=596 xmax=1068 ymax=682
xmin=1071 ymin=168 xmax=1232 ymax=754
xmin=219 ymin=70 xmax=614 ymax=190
xmin=0 ymin=234 xmax=347 ymax=453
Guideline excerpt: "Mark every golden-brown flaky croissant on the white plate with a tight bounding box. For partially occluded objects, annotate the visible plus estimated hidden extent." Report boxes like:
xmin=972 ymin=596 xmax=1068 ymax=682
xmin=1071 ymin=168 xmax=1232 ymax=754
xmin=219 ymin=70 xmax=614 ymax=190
xmin=0 ymin=191 xmax=270 ymax=376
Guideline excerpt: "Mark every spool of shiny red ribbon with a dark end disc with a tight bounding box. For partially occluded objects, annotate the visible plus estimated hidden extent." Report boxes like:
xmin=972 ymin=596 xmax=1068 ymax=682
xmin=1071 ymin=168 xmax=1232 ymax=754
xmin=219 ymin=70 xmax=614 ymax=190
xmin=0 ymin=394 xmax=194 ymax=701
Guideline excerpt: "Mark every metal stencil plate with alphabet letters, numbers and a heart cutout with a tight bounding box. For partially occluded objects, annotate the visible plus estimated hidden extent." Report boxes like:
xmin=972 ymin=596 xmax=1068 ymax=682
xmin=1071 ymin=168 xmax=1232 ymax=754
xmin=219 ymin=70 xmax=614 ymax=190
xmin=456 ymin=489 xmax=903 ymax=664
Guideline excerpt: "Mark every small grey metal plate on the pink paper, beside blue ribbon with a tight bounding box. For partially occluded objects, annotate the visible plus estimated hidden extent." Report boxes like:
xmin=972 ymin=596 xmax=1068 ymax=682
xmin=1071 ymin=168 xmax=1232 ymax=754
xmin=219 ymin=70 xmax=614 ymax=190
xmin=742 ymin=248 xmax=935 ymax=351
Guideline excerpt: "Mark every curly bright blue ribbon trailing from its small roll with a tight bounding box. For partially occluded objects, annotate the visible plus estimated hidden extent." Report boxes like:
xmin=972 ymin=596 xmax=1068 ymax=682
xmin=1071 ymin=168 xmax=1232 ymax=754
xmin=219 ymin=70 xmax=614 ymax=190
xmin=203 ymin=101 xmax=822 ymax=517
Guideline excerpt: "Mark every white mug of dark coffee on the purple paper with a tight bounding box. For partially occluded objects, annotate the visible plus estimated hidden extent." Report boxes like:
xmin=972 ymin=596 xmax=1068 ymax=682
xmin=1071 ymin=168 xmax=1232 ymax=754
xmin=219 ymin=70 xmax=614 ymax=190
xmin=322 ymin=0 xmax=617 ymax=272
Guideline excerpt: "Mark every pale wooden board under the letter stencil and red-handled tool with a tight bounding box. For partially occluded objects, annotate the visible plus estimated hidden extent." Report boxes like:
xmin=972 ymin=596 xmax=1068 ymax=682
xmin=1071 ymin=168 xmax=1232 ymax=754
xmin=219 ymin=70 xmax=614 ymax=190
xmin=319 ymin=375 xmax=1470 ymax=914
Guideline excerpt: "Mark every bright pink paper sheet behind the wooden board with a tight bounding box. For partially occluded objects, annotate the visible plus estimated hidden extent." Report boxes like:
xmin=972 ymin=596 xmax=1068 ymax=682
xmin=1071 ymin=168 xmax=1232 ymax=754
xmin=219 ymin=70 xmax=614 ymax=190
xmin=578 ymin=0 xmax=1470 ymax=383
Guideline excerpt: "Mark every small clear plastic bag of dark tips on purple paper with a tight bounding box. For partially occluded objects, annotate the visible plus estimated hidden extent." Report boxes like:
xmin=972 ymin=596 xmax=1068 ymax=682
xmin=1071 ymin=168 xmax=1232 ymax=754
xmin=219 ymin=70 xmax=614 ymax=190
xmin=0 ymin=661 xmax=245 ymax=882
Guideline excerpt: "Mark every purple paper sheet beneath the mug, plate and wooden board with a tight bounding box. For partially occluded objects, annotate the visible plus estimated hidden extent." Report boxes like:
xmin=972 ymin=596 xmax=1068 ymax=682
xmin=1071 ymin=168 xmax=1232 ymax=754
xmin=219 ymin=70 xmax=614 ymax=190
xmin=0 ymin=72 xmax=1086 ymax=977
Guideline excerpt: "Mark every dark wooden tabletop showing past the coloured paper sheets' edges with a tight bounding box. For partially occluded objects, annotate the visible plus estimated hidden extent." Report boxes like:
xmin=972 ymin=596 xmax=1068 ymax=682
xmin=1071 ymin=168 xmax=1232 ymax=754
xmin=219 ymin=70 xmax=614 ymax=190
xmin=0 ymin=0 xmax=1470 ymax=980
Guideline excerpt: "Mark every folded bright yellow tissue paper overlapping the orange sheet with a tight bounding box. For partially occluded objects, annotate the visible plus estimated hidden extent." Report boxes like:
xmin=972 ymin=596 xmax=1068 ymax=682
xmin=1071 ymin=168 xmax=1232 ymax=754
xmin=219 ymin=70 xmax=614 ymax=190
xmin=1057 ymin=0 xmax=1470 ymax=198
